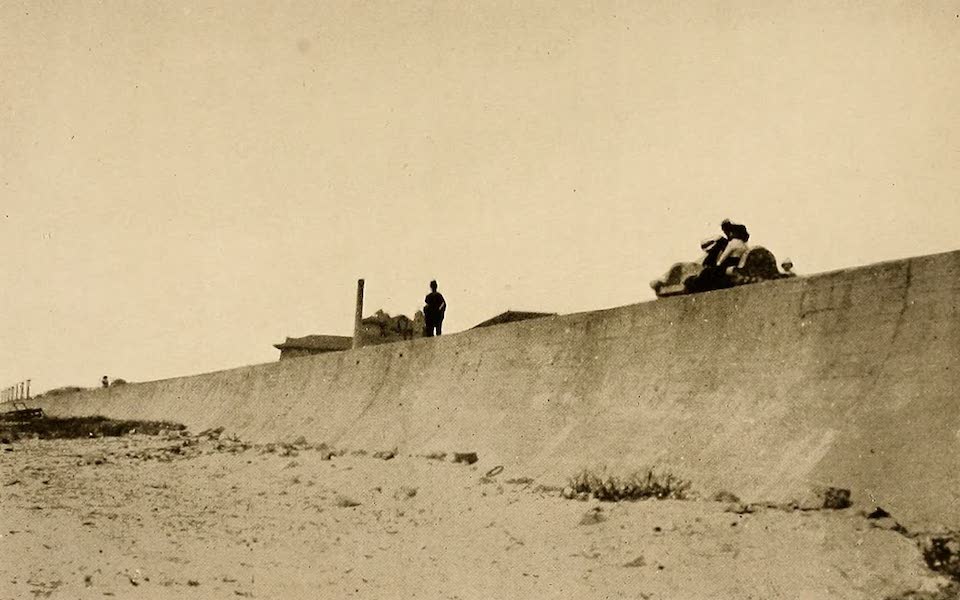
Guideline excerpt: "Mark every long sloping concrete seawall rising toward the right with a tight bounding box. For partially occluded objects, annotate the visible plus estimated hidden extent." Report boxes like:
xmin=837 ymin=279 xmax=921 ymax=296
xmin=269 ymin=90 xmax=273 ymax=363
xmin=30 ymin=252 xmax=960 ymax=529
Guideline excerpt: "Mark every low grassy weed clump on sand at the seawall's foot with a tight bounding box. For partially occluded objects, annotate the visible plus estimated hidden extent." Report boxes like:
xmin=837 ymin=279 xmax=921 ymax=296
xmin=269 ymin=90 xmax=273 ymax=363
xmin=567 ymin=469 xmax=690 ymax=502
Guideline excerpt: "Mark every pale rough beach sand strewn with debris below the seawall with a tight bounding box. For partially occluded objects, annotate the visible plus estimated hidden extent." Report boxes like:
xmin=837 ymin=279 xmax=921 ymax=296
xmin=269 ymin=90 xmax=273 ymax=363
xmin=0 ymin=435 xmax=943 ymax=600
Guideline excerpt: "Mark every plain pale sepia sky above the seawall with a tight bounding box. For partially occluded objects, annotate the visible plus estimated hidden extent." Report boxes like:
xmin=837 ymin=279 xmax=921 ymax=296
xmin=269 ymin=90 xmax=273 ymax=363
xmin=0 ymin=0 xmax=960 ymax=392
